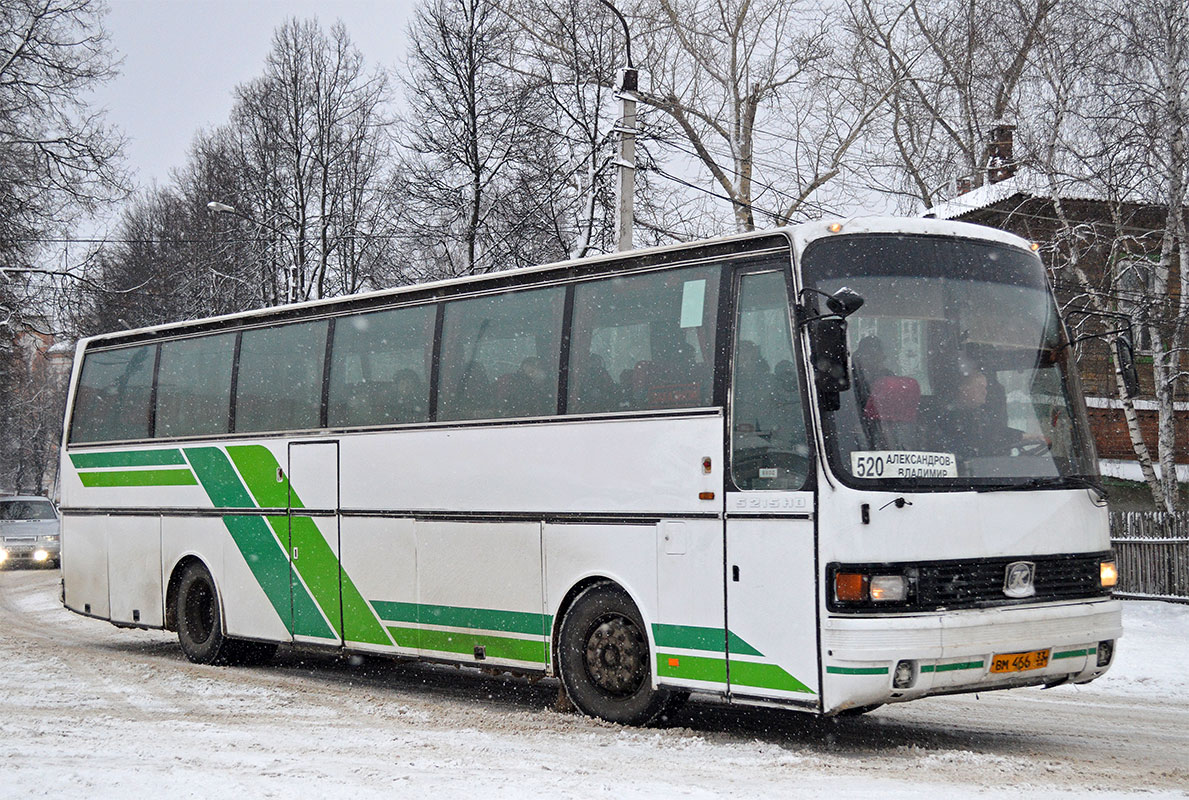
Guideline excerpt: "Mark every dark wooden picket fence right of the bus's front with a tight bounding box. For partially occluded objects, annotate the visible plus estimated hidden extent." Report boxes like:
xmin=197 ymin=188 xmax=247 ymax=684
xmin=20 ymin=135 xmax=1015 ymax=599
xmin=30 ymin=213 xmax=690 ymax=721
xmin=1111 ymin=511 xmax=1189 ymax=603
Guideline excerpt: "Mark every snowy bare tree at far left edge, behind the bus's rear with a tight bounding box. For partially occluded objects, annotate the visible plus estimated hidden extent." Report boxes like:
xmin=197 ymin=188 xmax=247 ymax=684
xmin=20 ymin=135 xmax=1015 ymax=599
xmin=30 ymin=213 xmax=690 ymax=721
xmin=0 ymin=0 xmax=124 ymax=490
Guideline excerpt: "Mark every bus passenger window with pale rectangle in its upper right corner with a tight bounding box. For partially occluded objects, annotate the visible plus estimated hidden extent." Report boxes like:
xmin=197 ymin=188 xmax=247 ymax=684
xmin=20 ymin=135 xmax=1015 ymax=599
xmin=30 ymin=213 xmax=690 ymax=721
xmin=566 ymin=266 xmax=722 ymax=414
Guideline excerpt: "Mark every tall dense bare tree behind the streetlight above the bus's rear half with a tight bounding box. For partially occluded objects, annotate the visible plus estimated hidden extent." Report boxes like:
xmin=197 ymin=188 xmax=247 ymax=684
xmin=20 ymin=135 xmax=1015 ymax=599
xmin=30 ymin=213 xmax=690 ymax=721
xmin=213 ymin=19 xmax=391 ymax=303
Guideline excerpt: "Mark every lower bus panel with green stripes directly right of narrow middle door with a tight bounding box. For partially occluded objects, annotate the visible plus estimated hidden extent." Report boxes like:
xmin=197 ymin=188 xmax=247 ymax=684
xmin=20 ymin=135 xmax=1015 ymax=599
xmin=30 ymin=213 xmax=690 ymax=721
xmin=340 ymin=517 xmax=417 ymax=656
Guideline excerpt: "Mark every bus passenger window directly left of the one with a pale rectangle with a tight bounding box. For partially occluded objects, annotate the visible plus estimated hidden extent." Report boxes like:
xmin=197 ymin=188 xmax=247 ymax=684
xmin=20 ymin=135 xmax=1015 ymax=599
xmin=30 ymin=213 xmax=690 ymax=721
xmin=438 ymin=286 xmax=566 ymax=420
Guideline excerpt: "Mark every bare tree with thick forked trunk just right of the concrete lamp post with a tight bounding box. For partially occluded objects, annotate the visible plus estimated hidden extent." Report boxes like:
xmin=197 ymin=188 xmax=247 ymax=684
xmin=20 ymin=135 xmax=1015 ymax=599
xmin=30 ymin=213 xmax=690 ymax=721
xmin=633 ymin=0 xmax=881 ymax=231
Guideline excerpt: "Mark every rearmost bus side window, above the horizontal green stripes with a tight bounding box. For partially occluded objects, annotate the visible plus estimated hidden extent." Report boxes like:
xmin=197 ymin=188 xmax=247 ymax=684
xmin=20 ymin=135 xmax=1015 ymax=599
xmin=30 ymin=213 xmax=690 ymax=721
xmin=70 ymin=345 xmax=157 ymax=442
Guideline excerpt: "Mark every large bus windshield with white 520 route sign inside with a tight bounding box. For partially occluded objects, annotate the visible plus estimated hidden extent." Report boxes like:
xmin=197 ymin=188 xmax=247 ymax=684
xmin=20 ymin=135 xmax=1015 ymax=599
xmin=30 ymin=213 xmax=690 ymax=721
xmin=803 ymin=234 xmax=1097 ymax=490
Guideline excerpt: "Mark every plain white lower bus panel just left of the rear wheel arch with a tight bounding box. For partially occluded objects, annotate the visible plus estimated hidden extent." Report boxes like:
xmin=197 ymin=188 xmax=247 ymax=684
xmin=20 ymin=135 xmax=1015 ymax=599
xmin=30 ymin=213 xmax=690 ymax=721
xmin=107 ymin=517 xmax=165 ymax=628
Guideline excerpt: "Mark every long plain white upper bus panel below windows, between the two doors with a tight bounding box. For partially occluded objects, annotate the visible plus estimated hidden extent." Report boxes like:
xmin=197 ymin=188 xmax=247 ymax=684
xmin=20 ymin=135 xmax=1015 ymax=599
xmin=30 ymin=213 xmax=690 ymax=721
xmin=339 ymin=414 xmax=723 ymax=518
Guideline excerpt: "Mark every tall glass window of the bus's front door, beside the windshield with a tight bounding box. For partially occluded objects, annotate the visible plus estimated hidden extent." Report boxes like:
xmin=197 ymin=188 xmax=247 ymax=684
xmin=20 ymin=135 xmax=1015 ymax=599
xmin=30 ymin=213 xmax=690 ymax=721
xmin=731 ymin=271 xmax=809 ymax=490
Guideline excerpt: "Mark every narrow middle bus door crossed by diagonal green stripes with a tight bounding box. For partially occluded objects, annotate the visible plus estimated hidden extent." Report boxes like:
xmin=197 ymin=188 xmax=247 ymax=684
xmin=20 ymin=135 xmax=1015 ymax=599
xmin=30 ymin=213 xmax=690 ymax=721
xmin=288 ymin=441 xmax=342 ymax=644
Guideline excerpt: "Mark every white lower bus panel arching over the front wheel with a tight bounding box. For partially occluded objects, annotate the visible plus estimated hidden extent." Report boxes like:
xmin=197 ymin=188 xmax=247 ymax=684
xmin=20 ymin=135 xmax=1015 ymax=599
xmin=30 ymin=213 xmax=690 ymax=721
xmin=545 ymin=523 xmax=661 ymax=685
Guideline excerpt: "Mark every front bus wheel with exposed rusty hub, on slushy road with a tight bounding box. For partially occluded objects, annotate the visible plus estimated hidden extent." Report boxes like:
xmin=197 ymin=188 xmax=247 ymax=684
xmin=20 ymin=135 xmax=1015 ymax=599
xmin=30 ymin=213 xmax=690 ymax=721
xmin=558 ymin=584 xmax=669 ymax=725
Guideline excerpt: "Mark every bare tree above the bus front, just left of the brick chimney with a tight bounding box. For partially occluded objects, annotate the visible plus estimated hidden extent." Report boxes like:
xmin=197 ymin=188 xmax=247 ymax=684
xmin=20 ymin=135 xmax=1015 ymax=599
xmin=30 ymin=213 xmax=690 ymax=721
xmin=850 ymin=0 xmax=1057 ymax=210
